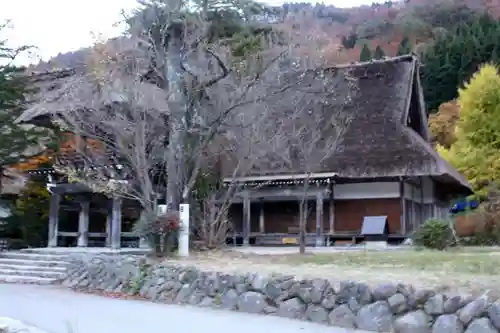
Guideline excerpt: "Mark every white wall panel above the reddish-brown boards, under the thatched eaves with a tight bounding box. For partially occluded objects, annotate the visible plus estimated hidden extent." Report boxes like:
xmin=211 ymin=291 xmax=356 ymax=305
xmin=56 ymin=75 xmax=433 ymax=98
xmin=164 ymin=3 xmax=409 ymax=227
xmin=333 ymin=182 xmax=399 ymax=199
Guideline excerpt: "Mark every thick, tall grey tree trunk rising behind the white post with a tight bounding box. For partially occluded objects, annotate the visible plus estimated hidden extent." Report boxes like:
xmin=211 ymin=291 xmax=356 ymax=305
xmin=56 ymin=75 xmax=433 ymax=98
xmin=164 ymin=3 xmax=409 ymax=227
xmin=165 ymin=22 xmax=186 ymax=211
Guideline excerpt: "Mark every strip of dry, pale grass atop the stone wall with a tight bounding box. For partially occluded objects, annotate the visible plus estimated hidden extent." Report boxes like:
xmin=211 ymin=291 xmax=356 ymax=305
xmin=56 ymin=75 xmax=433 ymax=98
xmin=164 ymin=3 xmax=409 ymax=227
xmin=161 ymin=248 xmax=500 ymax=296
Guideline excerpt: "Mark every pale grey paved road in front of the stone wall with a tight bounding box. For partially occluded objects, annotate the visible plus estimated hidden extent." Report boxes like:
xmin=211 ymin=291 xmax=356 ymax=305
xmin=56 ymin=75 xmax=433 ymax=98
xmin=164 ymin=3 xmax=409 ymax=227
xmin=0 ymin=284 xmax=372 ymax=333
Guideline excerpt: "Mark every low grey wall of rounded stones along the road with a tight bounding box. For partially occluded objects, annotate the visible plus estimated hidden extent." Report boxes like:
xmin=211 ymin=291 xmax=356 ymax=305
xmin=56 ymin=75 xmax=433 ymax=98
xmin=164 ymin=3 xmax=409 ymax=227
xmin=62 ymin=256 xmax=500 ymax=333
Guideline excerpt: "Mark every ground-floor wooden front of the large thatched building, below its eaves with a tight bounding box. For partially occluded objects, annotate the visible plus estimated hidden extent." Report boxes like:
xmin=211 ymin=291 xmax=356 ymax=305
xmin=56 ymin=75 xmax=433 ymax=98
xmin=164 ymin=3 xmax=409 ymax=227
xmin=223 ymin=177 xmax=446 ymax=246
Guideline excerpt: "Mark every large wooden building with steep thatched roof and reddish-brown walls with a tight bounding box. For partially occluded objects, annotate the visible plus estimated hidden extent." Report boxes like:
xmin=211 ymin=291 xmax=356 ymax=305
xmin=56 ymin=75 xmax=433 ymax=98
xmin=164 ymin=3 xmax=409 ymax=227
xmin=221 ymin=55 xmax=471 ymax=245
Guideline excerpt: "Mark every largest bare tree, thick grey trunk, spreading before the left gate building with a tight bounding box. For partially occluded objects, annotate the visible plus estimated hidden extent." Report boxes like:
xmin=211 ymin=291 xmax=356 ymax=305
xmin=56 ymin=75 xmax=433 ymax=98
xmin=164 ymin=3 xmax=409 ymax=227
xmin=23 ymin=1 xmax=296 ymax=249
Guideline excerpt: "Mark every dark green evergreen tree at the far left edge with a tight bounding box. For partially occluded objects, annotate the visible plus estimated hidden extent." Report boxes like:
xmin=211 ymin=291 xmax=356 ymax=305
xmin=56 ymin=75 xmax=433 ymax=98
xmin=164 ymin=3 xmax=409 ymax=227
xmin=0 ymin=24 xmax=51 ymax=191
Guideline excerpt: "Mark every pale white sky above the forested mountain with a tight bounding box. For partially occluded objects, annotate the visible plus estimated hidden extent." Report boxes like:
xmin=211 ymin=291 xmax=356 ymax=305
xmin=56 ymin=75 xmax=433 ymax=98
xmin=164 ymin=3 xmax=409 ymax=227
xmin=0 ymin=0 xmax=372 ymax=65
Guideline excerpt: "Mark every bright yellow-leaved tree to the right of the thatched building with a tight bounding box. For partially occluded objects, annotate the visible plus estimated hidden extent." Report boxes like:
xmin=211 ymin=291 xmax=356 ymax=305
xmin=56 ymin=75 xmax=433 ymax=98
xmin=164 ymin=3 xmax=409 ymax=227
xmin=437 ymin=64 xmax=500 ymax=197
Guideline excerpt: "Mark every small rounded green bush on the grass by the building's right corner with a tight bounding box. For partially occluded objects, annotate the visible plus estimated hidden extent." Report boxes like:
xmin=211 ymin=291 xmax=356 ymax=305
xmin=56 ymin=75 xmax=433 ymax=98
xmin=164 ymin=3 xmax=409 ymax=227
xmin=413 ymin=219 xmax=455 ymax=250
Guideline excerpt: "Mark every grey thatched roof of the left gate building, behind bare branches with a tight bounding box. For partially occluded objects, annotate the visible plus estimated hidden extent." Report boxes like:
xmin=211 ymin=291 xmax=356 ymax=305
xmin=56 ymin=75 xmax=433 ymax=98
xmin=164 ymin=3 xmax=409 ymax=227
xmin=17 ymin=38 xmax=166 ymax=123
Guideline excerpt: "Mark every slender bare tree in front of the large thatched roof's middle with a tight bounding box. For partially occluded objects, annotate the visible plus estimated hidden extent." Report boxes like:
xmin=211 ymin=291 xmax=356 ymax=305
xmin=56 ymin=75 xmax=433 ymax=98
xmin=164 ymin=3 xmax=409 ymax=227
xmin=264 ymin=67 xmax=357 ymax=253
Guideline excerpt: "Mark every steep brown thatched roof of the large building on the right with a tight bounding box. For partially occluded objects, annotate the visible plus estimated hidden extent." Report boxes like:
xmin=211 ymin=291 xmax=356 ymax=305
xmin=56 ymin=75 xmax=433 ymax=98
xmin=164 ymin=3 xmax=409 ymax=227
xmin=227 ymin=55 xmax=471 ymax=193
